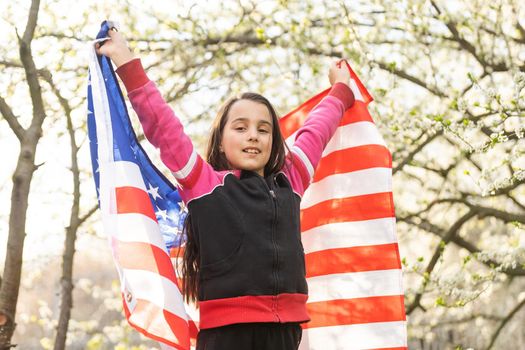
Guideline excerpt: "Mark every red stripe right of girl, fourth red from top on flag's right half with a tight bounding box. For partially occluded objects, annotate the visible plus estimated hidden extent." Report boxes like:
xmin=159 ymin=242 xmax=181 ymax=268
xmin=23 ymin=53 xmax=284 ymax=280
xmin=305 ymin=243 xmax=401 ymax=277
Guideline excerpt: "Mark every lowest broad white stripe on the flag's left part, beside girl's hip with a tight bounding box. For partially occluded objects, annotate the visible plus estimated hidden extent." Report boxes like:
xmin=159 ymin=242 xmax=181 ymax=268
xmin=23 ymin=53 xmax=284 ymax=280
xmin=121 ymin=269 xmax=188 ymax=320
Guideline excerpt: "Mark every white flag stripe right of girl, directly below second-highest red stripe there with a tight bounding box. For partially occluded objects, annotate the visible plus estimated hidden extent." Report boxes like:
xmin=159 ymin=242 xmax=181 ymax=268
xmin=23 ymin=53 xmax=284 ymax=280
xmin=301 ymin=168 xmax=392 ymax=209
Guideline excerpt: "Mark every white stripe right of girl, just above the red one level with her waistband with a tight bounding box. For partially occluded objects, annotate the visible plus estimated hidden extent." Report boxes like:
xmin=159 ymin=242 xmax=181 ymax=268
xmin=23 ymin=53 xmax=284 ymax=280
xmin=306 ymin=269 xmax=403 ymax=303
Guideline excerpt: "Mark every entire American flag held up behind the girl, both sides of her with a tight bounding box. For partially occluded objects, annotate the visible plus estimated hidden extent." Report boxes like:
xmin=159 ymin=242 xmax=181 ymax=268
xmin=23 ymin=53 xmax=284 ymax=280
xmin=88 ymin=22 xmax=407 ymax=350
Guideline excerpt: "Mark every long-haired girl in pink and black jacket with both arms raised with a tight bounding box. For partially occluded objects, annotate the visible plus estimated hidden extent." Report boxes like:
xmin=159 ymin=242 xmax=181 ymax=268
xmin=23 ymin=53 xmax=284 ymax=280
xmin=97 ymin=30 xmax=354 ymax=350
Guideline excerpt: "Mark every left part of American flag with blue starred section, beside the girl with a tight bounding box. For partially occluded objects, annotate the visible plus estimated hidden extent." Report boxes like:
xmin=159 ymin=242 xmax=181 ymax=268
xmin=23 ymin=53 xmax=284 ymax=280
xmin=88 ymin=22 xmax=197 ymax=349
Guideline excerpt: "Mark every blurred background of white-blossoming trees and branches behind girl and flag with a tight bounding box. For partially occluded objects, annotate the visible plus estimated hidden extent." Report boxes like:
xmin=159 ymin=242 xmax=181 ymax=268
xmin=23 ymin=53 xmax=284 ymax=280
xmin=0 ymin=0 xmax=525 ymax=350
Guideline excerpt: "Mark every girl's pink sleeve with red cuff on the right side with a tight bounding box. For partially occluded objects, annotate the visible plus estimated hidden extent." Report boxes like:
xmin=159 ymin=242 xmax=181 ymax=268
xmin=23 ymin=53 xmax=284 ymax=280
xmin=284 ymin=83 xmax=355 ymax=196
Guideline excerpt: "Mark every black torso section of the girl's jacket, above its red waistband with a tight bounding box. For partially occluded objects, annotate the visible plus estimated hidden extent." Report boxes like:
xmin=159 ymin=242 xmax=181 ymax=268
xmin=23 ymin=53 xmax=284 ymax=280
xmin=188 ymin=171 xmax=308 ymax=301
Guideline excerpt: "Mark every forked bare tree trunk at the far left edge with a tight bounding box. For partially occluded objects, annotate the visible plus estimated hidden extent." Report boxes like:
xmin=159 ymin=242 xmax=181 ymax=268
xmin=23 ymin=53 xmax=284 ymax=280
xmin=0 ymin=0 xmax=42 ymax=350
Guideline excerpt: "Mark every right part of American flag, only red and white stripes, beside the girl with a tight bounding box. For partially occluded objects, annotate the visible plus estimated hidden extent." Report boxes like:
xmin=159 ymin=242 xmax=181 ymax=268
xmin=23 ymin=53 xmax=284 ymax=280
xmin=280 ymin=65 xmax=407 ymax=350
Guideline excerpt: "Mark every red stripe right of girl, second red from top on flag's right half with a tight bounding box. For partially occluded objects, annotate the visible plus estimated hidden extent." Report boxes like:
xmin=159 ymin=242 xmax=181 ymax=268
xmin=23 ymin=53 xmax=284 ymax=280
xmin=313 ymin=145 xmax=392 ymax=182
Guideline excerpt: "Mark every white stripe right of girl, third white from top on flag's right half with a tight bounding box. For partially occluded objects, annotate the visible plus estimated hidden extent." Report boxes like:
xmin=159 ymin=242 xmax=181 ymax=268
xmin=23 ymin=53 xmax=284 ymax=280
xmin=301 ymin=218 xmax=397 ymax=254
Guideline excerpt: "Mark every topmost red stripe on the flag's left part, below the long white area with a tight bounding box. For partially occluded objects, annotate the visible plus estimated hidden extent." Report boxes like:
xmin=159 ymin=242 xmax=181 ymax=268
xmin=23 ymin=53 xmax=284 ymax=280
xmin=115 ymin=187 xmax=157 ymax=221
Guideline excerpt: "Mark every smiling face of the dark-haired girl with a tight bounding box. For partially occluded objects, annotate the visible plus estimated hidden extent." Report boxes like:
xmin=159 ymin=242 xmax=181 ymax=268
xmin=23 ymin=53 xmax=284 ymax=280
xmin=220 ymin=100 xmax=273 ymax=176
